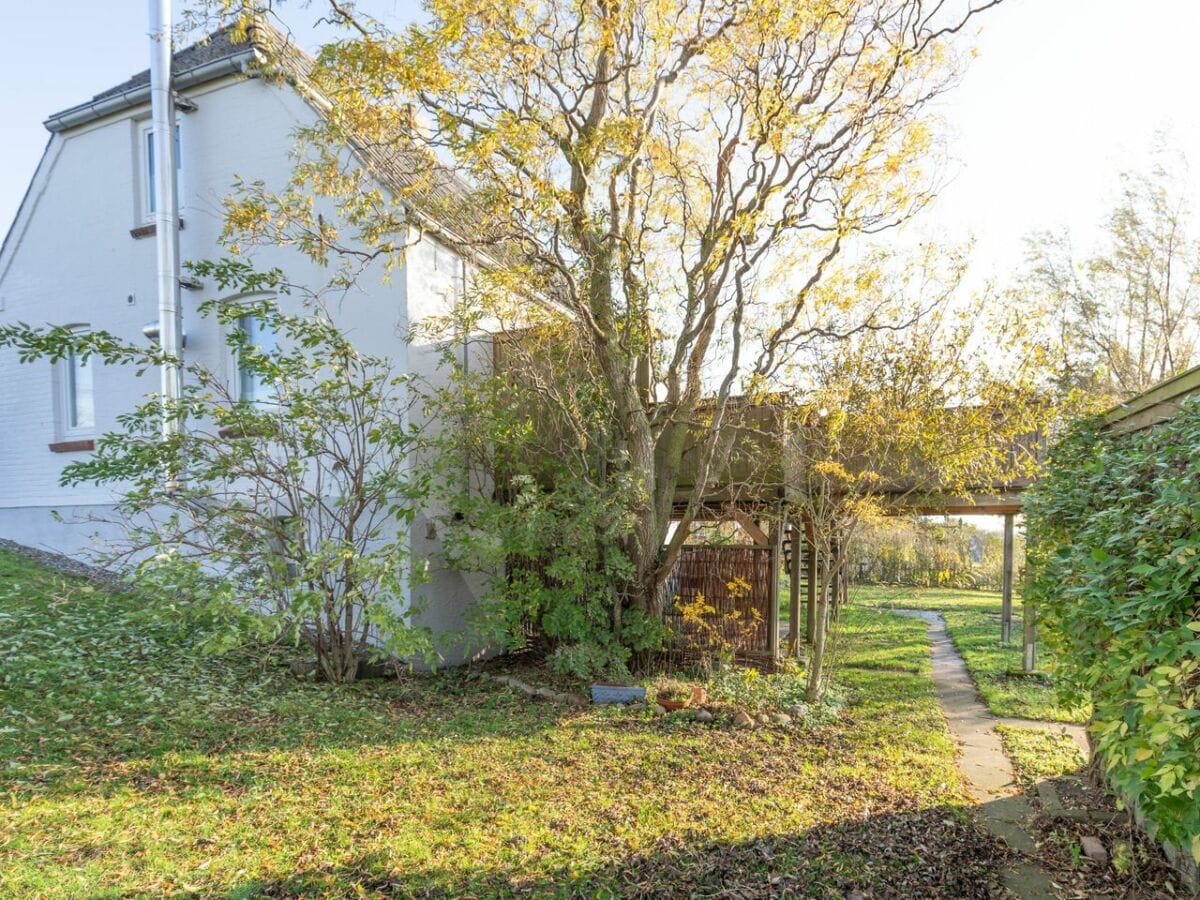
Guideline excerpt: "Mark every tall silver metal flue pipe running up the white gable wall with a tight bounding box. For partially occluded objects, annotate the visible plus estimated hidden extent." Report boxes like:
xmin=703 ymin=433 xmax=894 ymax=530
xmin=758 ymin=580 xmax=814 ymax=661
xmin=150 ymin=0 xmax=182 ymax=458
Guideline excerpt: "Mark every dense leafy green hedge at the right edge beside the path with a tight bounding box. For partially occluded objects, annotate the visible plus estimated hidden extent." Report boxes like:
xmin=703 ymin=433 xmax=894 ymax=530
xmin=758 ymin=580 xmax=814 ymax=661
xmin=1026 ymin=398 xmax=1200 ymax=862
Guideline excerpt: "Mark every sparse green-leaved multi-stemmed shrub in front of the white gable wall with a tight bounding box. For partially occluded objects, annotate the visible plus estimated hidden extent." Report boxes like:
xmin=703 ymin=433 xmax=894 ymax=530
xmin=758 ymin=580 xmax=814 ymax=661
xmin=0 ymin=263 xmax=433 ymax=683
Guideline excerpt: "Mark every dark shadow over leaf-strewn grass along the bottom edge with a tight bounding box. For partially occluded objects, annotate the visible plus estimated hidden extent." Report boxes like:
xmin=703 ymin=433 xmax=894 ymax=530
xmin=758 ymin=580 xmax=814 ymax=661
xmin=215 ymin=808 xmax=1007 ymax=898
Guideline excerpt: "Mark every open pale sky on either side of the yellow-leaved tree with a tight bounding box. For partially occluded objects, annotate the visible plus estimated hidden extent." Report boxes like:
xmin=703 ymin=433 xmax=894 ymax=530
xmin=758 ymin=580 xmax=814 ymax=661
xmin=0 ymin=0 xmax=1200 ymax=282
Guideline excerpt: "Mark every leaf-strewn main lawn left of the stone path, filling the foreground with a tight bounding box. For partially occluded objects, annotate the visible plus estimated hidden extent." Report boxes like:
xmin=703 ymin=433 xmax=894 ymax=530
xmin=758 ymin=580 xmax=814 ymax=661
xmin=0 ymin=552 xmax=998 ymax=896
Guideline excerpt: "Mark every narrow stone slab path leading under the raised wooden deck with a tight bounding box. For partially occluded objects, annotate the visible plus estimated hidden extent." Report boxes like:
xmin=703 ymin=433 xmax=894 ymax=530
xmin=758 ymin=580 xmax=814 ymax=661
xmin=890 ymin=610 xmax=1065 ymax=900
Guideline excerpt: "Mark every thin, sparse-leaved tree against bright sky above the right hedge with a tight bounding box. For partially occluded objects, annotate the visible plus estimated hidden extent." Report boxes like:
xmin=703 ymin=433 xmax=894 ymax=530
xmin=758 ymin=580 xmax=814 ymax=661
xmin=1026 ymin=151 xmax=1200 ymax=404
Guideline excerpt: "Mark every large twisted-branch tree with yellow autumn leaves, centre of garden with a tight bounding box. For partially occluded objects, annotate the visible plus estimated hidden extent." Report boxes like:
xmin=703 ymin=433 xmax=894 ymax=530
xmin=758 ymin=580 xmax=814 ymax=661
xmin=208 ymin=0 xmax=998 ymax=613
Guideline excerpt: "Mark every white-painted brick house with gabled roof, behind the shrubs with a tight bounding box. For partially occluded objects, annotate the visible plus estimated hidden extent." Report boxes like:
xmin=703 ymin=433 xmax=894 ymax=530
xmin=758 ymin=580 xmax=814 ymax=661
xmin=0 ymin=24 xmax=490 ymax=655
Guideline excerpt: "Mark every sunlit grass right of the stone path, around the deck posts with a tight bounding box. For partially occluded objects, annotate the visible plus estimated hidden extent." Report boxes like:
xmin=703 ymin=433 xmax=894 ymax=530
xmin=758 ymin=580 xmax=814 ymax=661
xmin=850 ymin=584 xmax=1087 ymax=722
